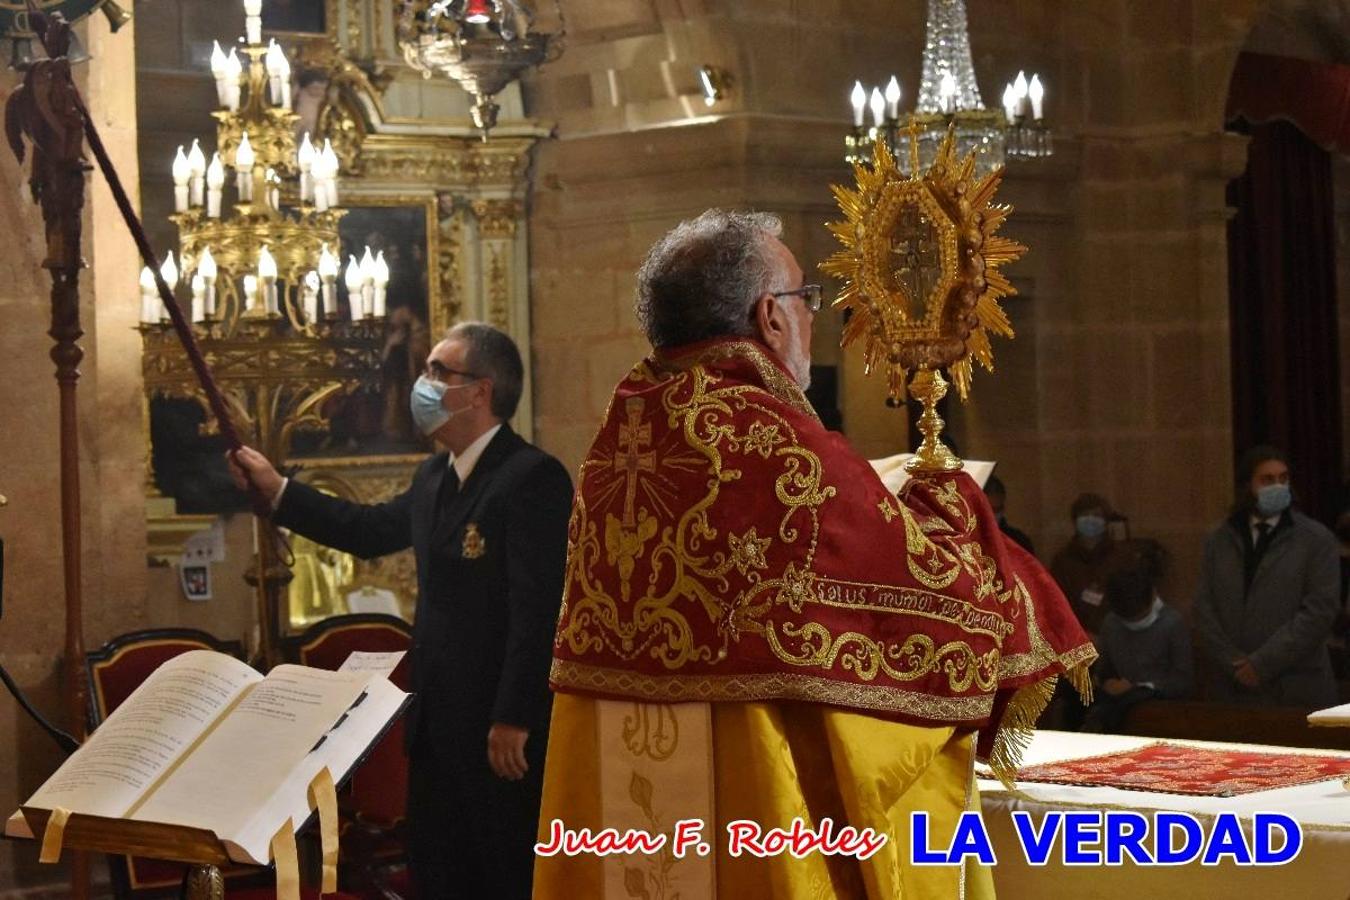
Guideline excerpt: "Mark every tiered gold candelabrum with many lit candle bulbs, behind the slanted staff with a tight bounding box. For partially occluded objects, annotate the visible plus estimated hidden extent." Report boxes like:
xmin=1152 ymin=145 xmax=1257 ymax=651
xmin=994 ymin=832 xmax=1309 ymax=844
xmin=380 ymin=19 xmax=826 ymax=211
xmin=140 ymin=0 xmax=390 ymax=660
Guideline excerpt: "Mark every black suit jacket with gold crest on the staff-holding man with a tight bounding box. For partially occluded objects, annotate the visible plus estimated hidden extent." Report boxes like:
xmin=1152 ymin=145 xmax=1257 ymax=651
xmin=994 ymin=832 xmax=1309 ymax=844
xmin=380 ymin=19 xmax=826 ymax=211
xmin=273 ymin=425 xmax=572 ymax=762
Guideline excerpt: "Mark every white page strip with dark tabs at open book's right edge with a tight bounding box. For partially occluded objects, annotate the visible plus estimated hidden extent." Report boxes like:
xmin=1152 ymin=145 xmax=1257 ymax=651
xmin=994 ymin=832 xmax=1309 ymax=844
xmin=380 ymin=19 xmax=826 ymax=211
xmin=225 ymin=677 xmax=408 ymax=861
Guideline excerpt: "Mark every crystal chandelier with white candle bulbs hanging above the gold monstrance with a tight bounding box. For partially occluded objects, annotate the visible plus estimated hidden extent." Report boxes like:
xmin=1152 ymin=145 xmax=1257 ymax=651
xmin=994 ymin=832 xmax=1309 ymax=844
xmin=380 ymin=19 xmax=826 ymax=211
xmin=844 ymin=0 xmax=1053 ymax=174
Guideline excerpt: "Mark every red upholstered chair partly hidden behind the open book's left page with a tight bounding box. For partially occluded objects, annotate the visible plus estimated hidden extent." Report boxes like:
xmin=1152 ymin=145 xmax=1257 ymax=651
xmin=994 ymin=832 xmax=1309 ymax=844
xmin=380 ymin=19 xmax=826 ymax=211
xmin=85 ymin=629 xmax=355 ymax=900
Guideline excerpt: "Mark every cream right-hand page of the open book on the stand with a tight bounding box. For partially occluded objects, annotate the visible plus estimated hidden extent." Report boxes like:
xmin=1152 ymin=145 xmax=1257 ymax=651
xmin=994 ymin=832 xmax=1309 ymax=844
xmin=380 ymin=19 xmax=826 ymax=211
xmin=130 ymin=665 xmax=371 ymax=864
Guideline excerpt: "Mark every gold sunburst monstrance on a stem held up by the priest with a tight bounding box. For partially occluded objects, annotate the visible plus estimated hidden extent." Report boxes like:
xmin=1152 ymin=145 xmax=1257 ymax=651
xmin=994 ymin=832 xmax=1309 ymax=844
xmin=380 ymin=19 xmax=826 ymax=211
xmin=821 ymin=131 xmax=1026 ymax=472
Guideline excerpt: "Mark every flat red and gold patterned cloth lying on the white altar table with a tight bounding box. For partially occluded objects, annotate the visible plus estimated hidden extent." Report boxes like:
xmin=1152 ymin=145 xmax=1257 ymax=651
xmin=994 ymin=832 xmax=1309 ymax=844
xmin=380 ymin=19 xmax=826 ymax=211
xmin=1017 ymin=741 xmax=1350 ymax=797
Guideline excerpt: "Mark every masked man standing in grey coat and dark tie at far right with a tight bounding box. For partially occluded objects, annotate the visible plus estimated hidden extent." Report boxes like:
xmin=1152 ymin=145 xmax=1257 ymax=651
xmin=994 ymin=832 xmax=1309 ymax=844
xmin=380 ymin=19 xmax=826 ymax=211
xmin=1195 ymin=447 xmax=1341 ymax=708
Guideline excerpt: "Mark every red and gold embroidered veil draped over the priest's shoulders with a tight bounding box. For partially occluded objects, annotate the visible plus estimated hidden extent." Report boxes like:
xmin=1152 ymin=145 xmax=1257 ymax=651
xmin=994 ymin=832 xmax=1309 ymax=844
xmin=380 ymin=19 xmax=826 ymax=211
xmin=551 ymin=340 xmax=1096 ymax=772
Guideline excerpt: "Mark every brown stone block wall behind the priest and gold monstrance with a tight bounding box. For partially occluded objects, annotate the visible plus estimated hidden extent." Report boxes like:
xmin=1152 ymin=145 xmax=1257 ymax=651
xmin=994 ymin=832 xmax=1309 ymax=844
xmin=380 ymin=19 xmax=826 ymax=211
xmin=527 ymin=0 xmax=1296 ymax=606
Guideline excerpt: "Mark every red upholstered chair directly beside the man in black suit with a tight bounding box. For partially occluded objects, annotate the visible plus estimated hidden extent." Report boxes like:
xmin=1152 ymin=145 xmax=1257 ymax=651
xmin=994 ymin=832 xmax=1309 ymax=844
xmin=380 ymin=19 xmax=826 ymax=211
xmin=294 ymin=613 xmax=412 ymax=900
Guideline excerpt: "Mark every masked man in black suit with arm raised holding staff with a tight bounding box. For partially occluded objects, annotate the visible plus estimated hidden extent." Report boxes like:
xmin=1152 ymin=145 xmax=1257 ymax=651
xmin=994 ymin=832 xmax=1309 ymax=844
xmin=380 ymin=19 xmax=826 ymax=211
xmin=231 ymin=322 xmax=572 ymax=900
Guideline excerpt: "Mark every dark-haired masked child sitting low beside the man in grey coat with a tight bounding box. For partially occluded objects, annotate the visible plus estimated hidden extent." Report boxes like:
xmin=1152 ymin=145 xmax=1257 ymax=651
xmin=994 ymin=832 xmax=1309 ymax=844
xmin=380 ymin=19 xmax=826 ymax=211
xmin=1083 ymin=560 xmax=1193 ymax=734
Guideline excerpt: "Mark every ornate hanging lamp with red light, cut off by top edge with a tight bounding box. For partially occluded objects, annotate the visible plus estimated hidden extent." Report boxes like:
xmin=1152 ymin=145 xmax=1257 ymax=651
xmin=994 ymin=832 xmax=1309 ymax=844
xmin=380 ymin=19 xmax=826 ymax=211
xmin=398 ymin=0 xmax=566 ymax=140
